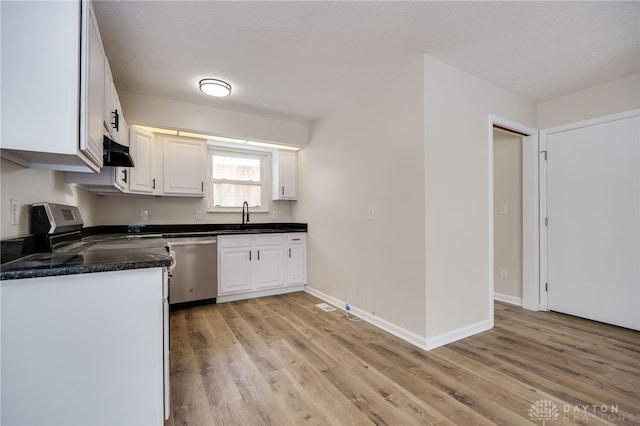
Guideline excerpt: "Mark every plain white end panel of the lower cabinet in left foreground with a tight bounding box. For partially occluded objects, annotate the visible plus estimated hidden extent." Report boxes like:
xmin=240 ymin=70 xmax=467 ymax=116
xmin=0 ymin=268 xmax=168 ymax=426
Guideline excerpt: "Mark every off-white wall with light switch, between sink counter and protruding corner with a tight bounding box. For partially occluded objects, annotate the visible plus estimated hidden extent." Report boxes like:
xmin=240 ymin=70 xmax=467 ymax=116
xmin=292 ymin=59 xmax=425 ymax=340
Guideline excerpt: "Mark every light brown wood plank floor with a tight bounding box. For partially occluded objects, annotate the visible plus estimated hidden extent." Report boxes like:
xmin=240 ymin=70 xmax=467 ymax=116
xmin=166 ymin=293 xmax=640 ymax=426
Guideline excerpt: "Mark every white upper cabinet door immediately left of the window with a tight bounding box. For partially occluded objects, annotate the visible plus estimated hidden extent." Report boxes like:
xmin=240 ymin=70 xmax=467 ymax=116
xmin=163 ymin=137 xmax=207 ymax=197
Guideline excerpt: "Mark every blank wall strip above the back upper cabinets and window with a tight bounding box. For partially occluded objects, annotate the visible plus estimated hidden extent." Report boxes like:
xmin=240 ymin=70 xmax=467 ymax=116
xmin=118 ymin=91 xmax=309 ymax=147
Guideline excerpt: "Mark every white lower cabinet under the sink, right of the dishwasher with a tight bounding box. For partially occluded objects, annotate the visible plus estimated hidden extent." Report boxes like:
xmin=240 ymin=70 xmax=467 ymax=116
xmin=216 ymin=233 xmax=307 ymax=303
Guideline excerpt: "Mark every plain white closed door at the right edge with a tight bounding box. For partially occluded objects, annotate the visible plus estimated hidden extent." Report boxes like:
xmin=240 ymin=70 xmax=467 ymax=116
xmin=546 ymin=116 xmax=640 ymax=329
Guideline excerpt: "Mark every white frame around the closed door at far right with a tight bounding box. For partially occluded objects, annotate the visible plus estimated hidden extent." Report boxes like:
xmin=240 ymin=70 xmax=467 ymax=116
xmin=539 ymin=108 xmax=640 ymax=311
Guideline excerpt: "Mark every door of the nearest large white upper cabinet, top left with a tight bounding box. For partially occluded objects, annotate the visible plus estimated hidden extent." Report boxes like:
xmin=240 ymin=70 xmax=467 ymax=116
xmin=80 ymin=3 xmax=106 ymax=167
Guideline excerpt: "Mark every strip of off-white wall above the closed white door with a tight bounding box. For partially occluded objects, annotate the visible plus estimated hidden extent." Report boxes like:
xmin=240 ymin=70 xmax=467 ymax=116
xmin=538 ymin=74 xmax=640 ymax=129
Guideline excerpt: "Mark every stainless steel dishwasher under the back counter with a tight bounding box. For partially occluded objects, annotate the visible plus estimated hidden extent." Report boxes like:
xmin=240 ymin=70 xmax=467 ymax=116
xmin=166 ymin=236 xmax=218 ymax=305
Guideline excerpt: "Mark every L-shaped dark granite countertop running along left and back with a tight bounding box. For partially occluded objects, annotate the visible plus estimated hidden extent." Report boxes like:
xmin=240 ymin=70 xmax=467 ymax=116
xmin=0 ymin=223 xmax=307 ymax=280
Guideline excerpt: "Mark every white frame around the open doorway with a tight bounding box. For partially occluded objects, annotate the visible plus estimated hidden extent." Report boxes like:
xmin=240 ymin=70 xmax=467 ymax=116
xmin=488 ymin=114 xmax=542 ymax=319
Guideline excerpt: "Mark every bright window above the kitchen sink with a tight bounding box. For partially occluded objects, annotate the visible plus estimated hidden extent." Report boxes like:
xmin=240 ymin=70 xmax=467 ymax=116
xmin=209 ymin=148 xmax=268 ymax=211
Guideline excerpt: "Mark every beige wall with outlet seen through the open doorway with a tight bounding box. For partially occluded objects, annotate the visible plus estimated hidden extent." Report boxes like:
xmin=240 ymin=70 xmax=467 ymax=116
xmin=493 ymin=130 xmax=523 ymax=303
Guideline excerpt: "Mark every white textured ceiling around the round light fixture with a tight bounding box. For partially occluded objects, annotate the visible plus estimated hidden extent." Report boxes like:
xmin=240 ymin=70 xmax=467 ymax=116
xmin=94 ymin=0 xmax=640 ymax=122
